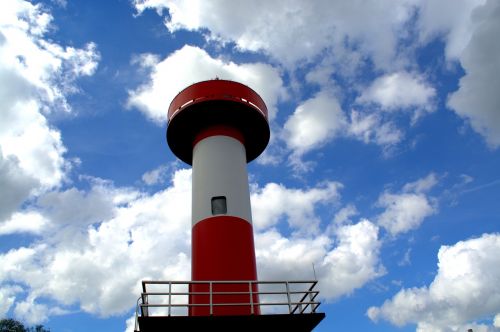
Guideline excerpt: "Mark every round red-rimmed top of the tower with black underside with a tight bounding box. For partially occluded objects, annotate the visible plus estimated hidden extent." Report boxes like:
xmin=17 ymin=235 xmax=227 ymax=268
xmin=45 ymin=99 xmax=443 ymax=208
xmin=167 ymin=79 xmax=270 ymax=165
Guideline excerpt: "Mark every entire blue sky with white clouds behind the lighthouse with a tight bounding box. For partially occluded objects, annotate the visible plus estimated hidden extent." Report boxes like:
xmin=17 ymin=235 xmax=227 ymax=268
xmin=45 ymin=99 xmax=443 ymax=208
xmin=0 ymin=0 xmax=500 ymax=332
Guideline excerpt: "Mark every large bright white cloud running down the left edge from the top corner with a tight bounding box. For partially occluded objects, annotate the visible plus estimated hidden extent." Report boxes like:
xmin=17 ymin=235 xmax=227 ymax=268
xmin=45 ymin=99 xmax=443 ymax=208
xmin=0 ymin=0 xmax=98 ymax=219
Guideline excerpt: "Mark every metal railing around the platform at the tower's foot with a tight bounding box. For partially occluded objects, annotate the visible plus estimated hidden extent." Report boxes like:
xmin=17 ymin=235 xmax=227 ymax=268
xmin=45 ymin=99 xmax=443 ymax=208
xmin=135 ymin=280 xmax=320 ymax=331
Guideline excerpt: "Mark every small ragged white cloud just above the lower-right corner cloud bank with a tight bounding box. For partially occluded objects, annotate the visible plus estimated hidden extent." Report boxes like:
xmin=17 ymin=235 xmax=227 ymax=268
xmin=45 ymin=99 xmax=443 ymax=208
xmin=377 ymin=173 xmax=437 ymax=236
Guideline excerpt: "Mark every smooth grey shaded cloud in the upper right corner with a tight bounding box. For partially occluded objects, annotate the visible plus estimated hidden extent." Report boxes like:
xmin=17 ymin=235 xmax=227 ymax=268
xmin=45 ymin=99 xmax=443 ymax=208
xmin=417 ymin=0 xmax=500 ymax=148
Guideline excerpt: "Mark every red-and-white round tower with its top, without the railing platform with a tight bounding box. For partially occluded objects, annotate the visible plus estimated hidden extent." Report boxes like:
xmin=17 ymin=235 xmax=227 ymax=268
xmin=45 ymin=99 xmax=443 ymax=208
xmin=167 ymin=79 xmax=270 ymax=316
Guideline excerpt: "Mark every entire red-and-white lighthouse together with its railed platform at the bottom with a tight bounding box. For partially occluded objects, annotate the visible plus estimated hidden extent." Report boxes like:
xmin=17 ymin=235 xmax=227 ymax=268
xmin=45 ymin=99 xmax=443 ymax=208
xmin=134 ymin=79 xmax=325 ymax=332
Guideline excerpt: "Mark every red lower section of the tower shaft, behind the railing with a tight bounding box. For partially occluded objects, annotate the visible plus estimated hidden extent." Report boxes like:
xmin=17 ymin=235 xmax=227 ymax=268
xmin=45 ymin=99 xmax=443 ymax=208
xmin=189 ymin=216 xmax=260 ymax=316
